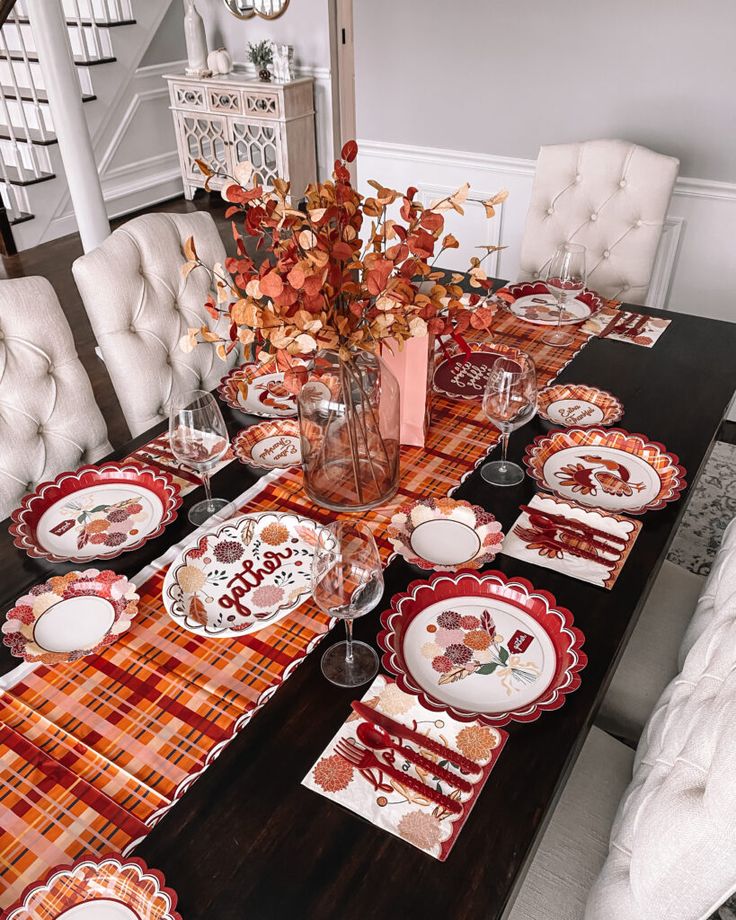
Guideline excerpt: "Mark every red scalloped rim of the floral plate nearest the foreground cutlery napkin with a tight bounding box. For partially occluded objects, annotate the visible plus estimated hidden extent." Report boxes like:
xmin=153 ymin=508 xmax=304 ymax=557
xmin=377 ymin=569 xmax=588 ymax=728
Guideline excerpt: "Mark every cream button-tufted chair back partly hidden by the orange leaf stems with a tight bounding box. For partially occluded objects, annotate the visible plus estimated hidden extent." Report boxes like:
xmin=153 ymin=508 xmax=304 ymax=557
xmin=72 ymin=212 xmax=236 ymax=437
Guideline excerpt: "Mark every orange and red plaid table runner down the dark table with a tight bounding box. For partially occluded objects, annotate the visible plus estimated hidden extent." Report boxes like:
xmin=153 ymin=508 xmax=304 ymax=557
xmin=0 ymin=304 xmax=616 ymax=907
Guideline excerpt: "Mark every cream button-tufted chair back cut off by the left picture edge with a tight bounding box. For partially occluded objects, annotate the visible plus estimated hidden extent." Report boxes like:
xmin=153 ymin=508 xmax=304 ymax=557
xmin=0 ymin=278 xmax=112 ymax=519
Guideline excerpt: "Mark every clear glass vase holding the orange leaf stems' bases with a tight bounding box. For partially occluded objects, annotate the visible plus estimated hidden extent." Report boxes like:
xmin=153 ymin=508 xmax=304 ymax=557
xmin=297 ymin=351 xmax=400 ymax=511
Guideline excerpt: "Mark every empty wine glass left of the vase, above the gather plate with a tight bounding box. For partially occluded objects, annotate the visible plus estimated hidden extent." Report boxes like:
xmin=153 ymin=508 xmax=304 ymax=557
xmin=169 ymin=390 xmax=230 ymax=527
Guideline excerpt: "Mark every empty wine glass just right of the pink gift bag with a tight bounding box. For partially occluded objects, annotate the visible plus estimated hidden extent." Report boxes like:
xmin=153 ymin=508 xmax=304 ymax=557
xmin=480 ymin=349 xmax=537 ymax=486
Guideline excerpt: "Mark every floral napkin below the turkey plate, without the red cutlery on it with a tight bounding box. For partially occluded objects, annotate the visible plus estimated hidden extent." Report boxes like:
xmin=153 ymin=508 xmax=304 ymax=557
xmin=501 ymin=493 xmax=642 ymax=590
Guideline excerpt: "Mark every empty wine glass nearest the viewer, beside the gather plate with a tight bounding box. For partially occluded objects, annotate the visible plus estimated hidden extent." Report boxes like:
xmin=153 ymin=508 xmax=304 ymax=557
xmin=312 ymin=521 xmax=383 ymax=687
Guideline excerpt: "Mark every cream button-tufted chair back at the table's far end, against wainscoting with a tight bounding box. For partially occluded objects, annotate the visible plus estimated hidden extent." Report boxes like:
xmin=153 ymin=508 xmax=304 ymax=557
xmin=520 ymin=140 xmax=680 ymax=303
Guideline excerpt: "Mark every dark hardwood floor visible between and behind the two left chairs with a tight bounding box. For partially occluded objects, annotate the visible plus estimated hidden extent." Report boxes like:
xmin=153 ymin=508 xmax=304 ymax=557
xmin=0 ymin=192 xmax=232 ymax=448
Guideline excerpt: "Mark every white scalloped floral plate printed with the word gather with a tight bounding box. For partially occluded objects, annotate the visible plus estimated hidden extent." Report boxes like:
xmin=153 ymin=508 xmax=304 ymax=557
xmin=163 ymin=511 xmax=330 ymax=638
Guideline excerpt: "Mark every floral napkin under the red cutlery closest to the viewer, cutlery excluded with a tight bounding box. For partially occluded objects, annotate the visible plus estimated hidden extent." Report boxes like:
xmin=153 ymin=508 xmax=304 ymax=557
xmin=302 ymin=674 xmax=508 ymax=861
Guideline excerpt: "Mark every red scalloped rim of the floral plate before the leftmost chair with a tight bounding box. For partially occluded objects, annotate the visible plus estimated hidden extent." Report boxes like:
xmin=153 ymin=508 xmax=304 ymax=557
xmin=8 ymin=460 xmax=182 ymax=564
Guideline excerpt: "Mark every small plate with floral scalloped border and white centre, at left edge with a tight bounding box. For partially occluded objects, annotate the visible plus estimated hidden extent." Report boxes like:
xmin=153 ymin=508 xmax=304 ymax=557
xmin=2 ymin=569 xmax=138 ymax=664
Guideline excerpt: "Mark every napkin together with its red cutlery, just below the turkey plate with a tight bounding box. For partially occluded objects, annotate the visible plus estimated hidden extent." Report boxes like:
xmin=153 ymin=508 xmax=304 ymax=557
xmin=501 ymin=494 xmax=642 ymax=590
